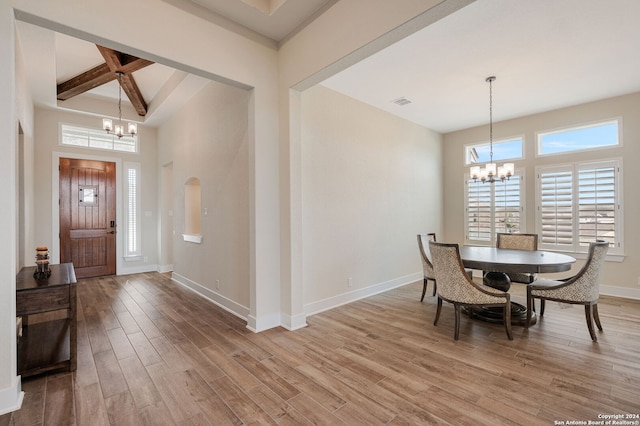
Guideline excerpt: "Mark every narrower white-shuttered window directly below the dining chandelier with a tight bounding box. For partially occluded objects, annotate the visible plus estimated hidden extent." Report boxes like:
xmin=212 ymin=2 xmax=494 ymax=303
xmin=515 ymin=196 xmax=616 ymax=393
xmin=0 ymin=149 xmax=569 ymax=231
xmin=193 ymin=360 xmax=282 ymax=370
xmin=465 ymin=170 xmax=524 ymax=244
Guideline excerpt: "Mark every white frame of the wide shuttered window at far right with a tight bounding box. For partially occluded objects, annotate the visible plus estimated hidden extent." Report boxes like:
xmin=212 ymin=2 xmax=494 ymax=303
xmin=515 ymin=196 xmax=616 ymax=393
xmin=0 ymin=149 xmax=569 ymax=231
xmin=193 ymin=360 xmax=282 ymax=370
xmin=535 ymin=157 xmax=624 ymax=256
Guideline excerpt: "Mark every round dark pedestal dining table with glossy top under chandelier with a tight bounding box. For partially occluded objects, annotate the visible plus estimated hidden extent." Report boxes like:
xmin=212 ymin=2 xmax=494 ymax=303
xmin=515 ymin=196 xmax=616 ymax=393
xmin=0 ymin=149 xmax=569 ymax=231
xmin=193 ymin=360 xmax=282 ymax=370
xmin=460 ymin=246 xmax=576 ymax=325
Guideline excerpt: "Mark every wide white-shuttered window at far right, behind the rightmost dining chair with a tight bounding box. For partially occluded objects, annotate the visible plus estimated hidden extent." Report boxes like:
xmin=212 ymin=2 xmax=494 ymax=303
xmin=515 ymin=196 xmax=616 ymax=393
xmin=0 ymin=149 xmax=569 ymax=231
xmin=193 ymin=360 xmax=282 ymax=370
xmin=536 ymin=160 xmax=623 ymax=254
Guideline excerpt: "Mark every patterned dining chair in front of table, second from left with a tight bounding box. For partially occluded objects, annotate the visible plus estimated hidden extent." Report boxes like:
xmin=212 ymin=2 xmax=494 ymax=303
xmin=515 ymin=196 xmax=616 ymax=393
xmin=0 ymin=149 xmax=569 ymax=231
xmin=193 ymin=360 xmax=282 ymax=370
xmin=429 ymin=241 xmax=513 ymax=340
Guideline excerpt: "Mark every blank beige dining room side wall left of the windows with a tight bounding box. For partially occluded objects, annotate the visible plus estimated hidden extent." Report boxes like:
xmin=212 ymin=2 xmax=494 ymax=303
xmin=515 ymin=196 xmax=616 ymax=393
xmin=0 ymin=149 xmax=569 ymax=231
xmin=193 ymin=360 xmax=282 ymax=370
xmin=302 ymin=86 xmax=443 ymax=314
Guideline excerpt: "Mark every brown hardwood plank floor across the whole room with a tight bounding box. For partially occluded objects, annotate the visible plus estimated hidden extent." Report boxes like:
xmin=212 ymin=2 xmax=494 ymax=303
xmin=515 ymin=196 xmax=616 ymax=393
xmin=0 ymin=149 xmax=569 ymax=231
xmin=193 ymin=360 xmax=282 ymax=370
xmin=0 ymin=273 xmax=640 ymax=426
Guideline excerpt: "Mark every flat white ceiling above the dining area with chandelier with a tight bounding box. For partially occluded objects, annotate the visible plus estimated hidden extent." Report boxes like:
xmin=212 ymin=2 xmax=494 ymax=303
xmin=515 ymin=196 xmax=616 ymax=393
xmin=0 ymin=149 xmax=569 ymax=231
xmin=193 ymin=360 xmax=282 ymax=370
xmin=323 ymin=0 xmax=640 ymax=133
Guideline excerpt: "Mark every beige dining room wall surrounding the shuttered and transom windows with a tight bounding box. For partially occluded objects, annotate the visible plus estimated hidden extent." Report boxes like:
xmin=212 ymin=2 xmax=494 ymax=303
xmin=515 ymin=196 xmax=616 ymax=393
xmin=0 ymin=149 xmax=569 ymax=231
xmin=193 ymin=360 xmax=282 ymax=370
xmin=444 ymin=93 xmax=640 ymax=298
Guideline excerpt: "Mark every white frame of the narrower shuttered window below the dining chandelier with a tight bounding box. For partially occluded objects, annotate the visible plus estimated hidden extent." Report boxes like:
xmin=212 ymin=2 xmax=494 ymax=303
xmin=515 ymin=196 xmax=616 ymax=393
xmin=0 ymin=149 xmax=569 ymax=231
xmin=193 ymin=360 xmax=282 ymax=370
xmin=464 ymin=167 xmax=527 ymax=246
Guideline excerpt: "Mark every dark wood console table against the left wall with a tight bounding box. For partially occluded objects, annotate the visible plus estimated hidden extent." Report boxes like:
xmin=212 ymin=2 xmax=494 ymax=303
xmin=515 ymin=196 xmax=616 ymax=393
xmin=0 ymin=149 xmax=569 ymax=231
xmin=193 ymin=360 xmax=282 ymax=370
xmin=16 ymin=263 xmax=77 ymax=377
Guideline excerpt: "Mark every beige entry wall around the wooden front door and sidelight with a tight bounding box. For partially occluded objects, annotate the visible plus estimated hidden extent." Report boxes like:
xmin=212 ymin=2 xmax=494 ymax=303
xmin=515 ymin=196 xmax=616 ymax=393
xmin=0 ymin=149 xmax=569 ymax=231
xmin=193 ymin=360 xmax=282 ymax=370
xmin=35 ymin=108 xmax=158 ymax=275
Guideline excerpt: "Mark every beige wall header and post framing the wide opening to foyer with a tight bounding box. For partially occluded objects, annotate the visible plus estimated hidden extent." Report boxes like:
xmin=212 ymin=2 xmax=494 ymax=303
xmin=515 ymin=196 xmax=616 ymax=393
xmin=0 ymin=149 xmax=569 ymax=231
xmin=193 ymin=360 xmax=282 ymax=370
xmin=10 ymin=0 xmax=280 ymax=330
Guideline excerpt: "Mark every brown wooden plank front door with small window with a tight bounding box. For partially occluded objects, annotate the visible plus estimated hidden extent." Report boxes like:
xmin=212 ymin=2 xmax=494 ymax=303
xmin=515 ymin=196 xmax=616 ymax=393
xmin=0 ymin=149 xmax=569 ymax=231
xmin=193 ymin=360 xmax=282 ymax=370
xmin=60 ymin=158 xmax=116 ymax=278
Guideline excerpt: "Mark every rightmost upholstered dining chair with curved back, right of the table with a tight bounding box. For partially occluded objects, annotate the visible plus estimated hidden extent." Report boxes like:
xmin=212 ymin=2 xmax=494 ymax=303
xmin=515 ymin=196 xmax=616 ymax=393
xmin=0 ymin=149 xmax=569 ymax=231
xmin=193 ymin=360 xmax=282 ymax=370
xmin=525 ymin=241 xmax=609 ymax=342
